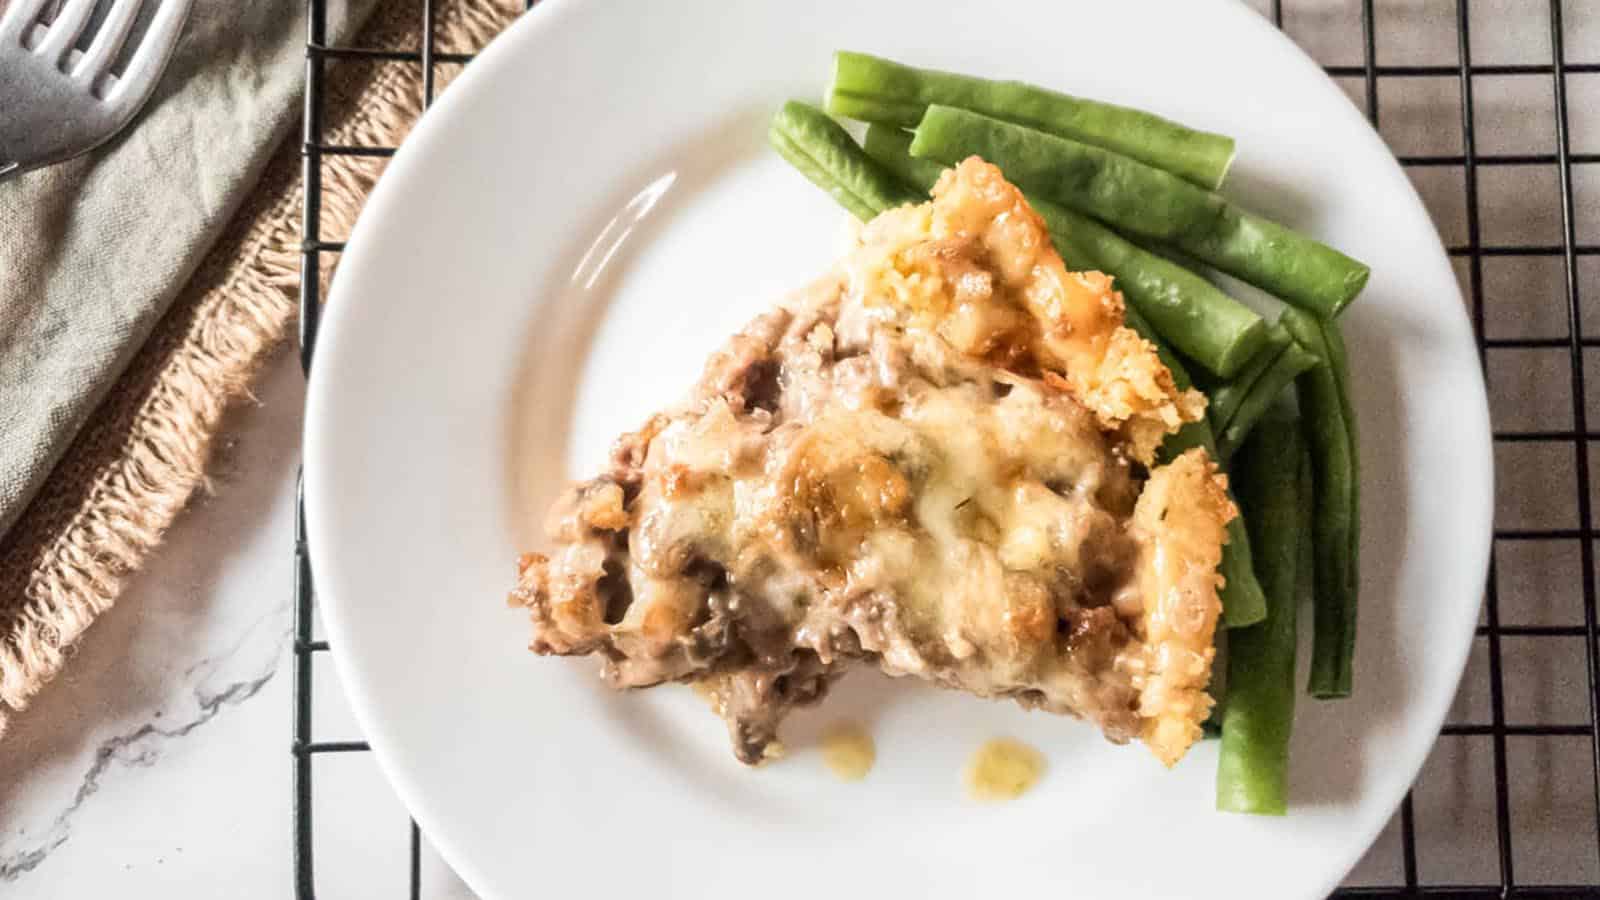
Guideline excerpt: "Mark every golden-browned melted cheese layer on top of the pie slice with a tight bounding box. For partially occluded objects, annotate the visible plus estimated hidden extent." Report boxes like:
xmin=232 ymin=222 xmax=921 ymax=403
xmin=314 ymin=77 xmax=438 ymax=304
xmin=621 ymin=347 xmax=1136 ymax=688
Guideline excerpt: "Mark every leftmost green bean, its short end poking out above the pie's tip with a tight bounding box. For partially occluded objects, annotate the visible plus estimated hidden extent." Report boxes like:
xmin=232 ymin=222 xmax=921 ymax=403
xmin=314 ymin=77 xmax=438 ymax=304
xmin=766 ymin=101 xmax=922 ymax=221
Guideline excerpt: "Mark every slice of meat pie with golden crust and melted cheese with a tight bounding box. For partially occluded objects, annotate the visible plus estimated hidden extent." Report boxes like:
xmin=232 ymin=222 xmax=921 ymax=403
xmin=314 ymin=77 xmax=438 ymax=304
xmin=510 ymin=159 xmax=1235 ymax=765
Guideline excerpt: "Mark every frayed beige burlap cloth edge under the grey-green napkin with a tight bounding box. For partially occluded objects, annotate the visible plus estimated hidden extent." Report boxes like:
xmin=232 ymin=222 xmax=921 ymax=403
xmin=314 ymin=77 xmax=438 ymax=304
xmin=0 ymin=0 xmax=523 ymax=733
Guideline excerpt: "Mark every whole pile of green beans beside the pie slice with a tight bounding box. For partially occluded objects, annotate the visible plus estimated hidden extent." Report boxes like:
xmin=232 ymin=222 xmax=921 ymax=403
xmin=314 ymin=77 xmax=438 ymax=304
xmin=770 ymin=51 xmax=1370 ymax=815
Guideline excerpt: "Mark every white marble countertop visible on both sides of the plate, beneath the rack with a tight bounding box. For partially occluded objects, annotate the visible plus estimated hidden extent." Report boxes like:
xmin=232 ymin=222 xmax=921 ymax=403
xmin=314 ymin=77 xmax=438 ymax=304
xmin=0 ymin=0 xmax=1600 ymax=898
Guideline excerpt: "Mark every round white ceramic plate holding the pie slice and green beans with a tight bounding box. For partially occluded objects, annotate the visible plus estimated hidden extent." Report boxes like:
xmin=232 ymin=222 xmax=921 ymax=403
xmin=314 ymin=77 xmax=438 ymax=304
xmin=306 ymin=0 xmax=1491 ymax=898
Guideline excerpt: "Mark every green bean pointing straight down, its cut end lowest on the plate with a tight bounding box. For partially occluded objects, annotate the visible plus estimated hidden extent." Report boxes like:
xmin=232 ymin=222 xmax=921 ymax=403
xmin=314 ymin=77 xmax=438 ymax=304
xmin=1216 ymin=418 xmax=1307 ymax=815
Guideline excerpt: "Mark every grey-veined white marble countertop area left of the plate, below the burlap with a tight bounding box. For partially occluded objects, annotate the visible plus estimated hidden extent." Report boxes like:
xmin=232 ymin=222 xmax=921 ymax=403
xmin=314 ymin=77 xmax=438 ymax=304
xmin=0 ymin=354 xmax=470 ymax=900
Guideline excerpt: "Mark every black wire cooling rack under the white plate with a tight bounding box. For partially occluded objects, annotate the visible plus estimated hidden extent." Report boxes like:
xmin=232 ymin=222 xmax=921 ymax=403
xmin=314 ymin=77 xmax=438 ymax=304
xmin=291 ymin=0 xmax=1600 ymax=900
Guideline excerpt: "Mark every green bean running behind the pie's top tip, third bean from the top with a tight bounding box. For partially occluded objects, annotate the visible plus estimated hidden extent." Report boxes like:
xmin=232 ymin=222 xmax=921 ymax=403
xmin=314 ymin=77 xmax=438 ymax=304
xmin=866 ymin=123 xmax=1267 ymax=376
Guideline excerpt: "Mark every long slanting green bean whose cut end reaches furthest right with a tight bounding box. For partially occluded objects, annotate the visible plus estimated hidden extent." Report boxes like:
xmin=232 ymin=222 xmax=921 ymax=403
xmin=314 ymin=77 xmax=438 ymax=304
xmin=910 ymin=106 xmax=1371 ymax=319
